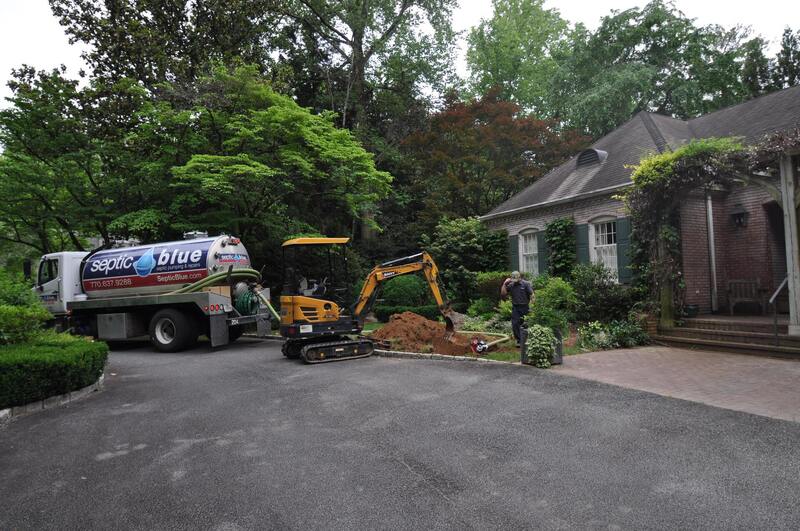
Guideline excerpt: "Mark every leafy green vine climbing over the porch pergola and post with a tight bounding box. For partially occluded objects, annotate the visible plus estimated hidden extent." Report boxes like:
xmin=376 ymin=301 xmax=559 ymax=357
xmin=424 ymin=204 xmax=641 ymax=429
xmin=621 ymin=129 xmax=800 ymax=326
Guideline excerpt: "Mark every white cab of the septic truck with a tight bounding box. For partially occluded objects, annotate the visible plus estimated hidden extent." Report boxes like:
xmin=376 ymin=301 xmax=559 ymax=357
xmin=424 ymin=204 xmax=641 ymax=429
xmin=33 ymin=252 xmax=89 ymax=318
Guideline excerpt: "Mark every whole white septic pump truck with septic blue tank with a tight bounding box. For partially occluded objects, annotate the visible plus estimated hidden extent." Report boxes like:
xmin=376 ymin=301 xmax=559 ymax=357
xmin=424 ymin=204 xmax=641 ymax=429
xmin=34 ymin=235 xmax=275 ymax=352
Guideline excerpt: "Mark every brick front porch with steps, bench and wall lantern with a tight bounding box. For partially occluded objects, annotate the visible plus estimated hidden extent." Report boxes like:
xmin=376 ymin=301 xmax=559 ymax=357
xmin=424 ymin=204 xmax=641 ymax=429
xmin=668 ymin=151 xmax=800 ymax=359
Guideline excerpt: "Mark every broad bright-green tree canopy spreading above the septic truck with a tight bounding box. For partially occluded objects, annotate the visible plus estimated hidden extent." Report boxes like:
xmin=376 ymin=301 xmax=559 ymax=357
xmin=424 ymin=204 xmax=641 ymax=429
xmin=0 ymin=67 xmax=391 ymax=265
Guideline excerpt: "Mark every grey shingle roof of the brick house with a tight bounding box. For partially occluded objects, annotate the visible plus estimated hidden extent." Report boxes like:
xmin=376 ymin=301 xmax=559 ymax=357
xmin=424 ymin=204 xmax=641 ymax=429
xmin=483 ymin=85 xmax=800 ymax=218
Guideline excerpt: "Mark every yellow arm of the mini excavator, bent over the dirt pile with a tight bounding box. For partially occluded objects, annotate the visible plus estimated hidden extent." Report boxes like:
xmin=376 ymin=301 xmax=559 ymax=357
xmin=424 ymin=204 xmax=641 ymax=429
xmin=353 ymin=251 xmax=455 ymax=334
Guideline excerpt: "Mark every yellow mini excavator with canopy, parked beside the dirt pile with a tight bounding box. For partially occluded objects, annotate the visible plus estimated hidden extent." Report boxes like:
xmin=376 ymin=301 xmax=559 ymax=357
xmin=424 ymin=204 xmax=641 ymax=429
xmin=280 ymin=238 xmax=454 ymax=363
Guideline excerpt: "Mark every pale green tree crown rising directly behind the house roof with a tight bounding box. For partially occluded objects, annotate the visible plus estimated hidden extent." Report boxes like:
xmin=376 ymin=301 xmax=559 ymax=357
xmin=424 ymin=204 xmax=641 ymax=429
xmin=551 ymin=0 xmax=747 ymax=136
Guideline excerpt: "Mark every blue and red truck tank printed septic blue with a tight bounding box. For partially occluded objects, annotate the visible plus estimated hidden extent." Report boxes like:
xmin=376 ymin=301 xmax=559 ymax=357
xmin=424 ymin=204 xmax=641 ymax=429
xmin=81 ymin=235 xmax=250 ymax=299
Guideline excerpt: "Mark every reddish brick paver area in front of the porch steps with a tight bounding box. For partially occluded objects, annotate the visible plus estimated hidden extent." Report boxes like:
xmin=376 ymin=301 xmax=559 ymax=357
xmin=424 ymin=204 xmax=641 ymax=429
xmin=556 ymin=346 xmax=800 ymax=422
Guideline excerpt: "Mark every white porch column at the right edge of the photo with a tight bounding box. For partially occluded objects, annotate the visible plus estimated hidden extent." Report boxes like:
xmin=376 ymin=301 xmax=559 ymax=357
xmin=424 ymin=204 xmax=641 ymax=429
xmin=781 ymin=153 xmax=800 ymax=336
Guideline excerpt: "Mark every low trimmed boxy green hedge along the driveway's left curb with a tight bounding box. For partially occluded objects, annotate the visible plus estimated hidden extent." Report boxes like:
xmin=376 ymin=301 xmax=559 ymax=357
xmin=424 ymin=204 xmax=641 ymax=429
xmin=0 ymin=333 xmax=108 ymax=408
